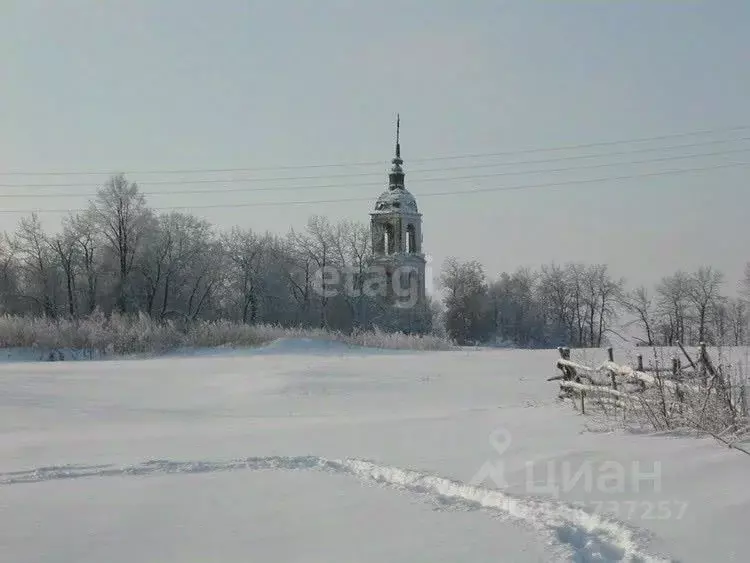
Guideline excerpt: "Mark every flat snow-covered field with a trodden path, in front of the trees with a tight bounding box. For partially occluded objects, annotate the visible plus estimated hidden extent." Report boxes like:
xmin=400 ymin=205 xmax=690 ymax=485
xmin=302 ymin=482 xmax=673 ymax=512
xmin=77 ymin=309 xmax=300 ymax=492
xmin=0 ymin=340 xmax=750 ymax=563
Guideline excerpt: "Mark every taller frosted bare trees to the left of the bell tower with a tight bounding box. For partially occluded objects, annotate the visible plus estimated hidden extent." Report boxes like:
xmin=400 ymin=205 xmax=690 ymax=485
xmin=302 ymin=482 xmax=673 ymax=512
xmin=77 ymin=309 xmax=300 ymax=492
xmin=0 ymin=175 xmax=432 ymax=332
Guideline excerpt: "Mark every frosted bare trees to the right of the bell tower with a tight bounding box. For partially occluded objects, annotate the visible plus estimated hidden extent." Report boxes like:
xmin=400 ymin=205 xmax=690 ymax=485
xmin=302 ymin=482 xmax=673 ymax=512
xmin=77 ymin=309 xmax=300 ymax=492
xmin=440 ymin=258 xmax=750 ymax=347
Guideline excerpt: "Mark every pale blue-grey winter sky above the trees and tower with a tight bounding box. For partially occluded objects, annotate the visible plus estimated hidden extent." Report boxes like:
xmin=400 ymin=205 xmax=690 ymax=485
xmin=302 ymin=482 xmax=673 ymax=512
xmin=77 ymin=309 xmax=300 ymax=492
xmin=0 ymin=0 xmax=750 ymax=290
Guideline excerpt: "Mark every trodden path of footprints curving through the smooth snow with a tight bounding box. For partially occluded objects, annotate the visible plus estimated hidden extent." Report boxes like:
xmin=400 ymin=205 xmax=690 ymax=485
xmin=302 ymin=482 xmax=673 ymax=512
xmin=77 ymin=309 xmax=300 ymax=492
xmin=0 ymin=456 xmax=671 ymax=563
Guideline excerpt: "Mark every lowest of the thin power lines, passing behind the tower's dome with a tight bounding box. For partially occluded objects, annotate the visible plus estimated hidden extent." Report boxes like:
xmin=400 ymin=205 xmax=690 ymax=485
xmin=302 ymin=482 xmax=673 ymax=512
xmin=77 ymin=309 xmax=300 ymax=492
xmin=0 ymin=161 xmax=750 ymax=217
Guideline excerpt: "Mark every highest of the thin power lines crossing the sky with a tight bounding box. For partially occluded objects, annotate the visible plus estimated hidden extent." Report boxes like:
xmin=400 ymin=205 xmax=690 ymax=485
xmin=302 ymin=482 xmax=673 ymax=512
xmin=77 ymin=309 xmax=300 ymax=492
xmin=0 ymin=125 xmax=750 ymax=176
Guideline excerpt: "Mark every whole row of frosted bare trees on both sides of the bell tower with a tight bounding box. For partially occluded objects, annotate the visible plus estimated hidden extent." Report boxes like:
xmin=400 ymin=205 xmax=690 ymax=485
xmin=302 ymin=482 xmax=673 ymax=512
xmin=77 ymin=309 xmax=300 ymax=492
xmin=0 ymin=175 xmax=750 ymax=348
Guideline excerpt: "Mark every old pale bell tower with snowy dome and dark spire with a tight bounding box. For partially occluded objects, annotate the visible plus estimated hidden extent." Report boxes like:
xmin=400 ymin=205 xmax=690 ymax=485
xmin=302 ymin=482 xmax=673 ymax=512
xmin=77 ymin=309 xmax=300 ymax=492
xmin=370 ymin=116 xmax=425 ymax=309
